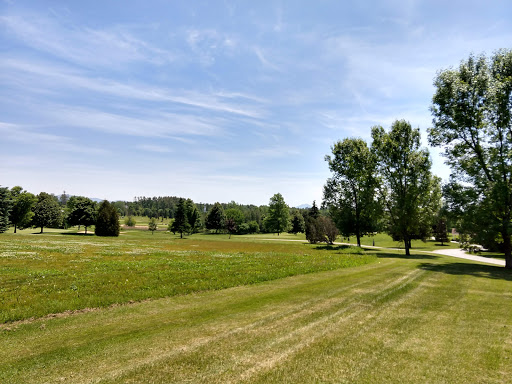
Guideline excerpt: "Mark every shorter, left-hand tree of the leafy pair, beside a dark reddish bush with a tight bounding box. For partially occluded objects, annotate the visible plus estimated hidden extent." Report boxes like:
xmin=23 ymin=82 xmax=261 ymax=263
xmin=324 ymin=138 xmax=378 ymax=247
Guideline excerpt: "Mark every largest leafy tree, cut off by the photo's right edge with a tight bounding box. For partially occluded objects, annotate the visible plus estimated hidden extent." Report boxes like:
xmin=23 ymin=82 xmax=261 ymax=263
xmin=429 ymin=50 xmax=512 ymax=269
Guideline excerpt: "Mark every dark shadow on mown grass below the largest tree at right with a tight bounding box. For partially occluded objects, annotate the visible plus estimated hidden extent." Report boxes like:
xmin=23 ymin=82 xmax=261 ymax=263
xmin=418 ymin=262 xmax=512 ymax=281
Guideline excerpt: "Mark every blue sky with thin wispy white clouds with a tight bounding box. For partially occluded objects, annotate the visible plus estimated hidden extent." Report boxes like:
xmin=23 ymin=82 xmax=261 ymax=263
xmin=0 ymin=0 xmax=512 ymax=206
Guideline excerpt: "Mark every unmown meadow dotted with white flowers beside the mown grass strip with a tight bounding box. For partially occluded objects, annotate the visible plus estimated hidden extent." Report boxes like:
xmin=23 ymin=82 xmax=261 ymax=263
xmin=0 ymin=230 xmax=375 ymax=323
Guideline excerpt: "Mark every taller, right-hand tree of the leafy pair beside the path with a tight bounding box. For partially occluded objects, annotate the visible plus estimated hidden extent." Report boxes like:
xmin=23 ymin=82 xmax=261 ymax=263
xmin=372 ymin=120 xmax=441 ymax=255
